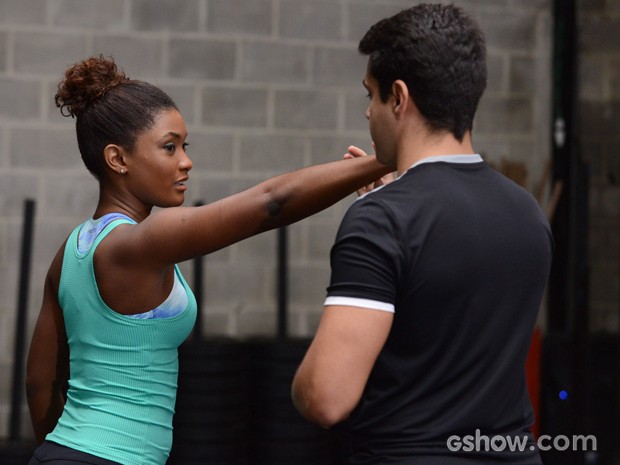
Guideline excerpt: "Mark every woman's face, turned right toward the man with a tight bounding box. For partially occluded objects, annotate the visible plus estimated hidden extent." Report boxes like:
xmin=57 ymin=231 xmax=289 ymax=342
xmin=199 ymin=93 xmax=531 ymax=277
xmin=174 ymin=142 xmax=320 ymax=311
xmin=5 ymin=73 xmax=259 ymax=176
xmin=126 ymin=109 xmax=192 ymax=207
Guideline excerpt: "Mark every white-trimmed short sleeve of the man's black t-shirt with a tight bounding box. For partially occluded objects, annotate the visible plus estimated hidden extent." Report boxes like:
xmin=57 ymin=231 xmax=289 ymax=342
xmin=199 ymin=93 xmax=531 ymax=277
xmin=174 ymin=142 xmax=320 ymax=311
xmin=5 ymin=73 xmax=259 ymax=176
xmin=325 ymin=197 xmax=403 ymax=312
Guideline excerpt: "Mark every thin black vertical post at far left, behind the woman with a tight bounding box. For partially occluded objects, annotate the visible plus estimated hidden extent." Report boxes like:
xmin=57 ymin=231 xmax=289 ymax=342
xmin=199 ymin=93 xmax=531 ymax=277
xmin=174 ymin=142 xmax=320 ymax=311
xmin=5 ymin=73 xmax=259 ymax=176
xmin=9 ymin=199 xmax=35 ymax=441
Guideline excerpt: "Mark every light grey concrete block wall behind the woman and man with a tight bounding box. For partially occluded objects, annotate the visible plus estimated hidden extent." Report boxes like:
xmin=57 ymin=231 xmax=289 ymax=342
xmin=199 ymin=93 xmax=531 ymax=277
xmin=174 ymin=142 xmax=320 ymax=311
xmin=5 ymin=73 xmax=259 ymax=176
xmin=0 ymin=0 xmax=552 ymax=437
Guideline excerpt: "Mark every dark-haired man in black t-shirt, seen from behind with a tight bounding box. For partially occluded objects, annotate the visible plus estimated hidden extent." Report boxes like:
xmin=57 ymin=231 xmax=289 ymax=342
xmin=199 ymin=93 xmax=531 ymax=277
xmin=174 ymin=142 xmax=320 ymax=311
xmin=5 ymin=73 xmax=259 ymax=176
xmin=293 ymin=4 xmax=552 ymax=465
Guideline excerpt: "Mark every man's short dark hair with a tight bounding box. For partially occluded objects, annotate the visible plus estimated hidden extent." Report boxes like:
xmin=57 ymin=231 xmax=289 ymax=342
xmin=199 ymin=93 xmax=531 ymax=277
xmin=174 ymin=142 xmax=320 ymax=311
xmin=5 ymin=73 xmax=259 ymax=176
xmin=358 ymin=4 xmax=487 ymax=141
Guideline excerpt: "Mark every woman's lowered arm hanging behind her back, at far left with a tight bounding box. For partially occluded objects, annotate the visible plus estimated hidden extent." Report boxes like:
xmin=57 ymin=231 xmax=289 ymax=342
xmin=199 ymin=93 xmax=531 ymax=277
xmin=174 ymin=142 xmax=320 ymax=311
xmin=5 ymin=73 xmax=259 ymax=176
xmin=26 ymin=245 xmax=69 ymax=443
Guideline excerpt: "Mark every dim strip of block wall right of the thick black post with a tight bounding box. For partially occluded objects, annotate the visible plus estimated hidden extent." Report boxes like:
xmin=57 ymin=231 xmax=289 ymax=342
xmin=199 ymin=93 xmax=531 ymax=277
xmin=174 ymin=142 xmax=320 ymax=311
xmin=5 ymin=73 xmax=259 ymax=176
xmin=578 ymin=0 xmax=620 ymax=333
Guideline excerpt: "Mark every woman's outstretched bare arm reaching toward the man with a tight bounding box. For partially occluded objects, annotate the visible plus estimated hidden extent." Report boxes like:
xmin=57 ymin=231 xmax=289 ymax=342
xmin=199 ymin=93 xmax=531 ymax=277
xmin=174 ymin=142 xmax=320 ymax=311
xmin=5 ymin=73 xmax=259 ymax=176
xmin=117 ymin=156 xmax=390 ymax=266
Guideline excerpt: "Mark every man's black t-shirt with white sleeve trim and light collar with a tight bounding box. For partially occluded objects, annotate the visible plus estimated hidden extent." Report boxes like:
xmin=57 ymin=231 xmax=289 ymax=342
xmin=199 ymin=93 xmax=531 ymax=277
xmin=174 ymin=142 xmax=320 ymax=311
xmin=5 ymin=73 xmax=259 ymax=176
xmin=326 ymin=156 xmax=553 ymax=465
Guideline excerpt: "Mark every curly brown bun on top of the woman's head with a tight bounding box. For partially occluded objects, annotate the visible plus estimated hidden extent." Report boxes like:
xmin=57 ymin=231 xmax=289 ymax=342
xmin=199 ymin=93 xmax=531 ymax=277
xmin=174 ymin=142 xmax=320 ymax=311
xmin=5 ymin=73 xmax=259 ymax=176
xmin=54 ymin=55 xmax=129 ymax=117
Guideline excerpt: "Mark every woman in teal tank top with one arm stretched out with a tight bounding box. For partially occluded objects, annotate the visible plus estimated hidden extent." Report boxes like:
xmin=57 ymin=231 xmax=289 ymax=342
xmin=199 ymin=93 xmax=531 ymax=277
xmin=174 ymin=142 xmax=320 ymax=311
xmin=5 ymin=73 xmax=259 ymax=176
xmin=27 ymin=57 xmax=389 ymax=465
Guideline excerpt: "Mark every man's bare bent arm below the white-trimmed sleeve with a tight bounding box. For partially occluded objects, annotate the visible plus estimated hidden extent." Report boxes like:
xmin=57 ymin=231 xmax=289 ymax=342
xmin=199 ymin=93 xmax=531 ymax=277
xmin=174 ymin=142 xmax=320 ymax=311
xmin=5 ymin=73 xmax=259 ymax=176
xmin=292 ymin=305 xmax=394 ymax=428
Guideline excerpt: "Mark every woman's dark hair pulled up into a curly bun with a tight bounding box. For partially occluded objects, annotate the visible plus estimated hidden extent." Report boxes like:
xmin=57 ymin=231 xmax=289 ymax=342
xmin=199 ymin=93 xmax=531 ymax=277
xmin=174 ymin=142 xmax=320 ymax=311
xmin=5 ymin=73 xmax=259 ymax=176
xmin=54 ymin=55 xmax=177 ymax=180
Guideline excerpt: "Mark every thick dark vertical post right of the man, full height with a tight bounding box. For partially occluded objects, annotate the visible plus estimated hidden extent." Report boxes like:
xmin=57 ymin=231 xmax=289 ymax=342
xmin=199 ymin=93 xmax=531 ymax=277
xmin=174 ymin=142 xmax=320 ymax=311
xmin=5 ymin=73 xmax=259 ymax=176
xmin=542 ymin=0 xmax=588 ymax=465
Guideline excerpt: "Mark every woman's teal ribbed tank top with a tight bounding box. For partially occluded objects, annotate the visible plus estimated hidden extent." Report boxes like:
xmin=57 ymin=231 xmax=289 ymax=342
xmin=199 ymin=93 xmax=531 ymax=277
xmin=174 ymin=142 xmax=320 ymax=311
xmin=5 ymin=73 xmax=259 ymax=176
xmin=46 ymin=219 xmax=196 ymax=465
